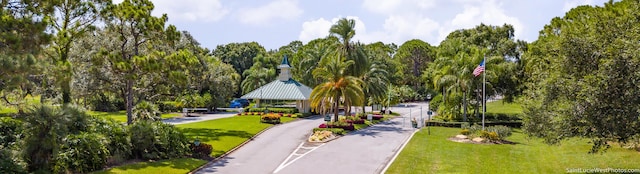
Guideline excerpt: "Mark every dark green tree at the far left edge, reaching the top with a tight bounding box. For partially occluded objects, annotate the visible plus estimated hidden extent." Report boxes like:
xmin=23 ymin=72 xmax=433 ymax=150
xmin=0 ymin=0 xmax=53 ymax=106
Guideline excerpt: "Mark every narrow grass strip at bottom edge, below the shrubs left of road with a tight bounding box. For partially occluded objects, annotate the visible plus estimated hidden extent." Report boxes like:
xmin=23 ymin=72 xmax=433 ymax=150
xmin=95 ymin=158 xmax=207 ymax=174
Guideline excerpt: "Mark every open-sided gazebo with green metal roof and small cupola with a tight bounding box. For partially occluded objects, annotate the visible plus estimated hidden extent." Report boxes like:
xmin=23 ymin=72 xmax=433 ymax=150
xmin=240 ymin=56 xmax=311 ymax=113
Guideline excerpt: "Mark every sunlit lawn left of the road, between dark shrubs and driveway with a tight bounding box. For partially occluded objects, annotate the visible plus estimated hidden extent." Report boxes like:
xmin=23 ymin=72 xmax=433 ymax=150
xmin=176 ymin=116 xmax=295 ymax=157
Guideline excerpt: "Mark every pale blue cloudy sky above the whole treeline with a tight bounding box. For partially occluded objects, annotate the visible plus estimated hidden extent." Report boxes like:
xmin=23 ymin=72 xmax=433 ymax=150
xmin=114 ymin=0 xmax=607 ymax=50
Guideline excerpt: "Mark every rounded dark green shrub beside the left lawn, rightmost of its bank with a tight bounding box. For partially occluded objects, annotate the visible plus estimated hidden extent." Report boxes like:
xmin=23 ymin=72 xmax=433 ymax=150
xmin=129 ymin=121 xmax=190 ymax=160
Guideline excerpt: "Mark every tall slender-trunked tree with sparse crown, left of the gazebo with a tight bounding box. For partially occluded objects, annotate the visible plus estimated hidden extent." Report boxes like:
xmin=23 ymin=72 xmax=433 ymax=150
xmin=103 ymin=0 xmax=180 ymax=124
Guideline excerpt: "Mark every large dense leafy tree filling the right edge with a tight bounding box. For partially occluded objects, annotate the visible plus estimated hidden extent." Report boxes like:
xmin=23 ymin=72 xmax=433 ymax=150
xmin=523 ymin=0 xmax=640 ymax=152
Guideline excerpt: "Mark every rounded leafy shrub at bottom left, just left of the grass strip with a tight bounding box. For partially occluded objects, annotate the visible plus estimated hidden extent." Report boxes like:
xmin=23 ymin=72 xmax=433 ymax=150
xmin=53 ymin=132 xmax=109 ymax=173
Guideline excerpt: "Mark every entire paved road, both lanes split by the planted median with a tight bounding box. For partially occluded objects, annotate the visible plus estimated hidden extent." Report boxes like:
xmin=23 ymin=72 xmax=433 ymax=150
xmin=190 ymin=103 xmax=426 ymax=174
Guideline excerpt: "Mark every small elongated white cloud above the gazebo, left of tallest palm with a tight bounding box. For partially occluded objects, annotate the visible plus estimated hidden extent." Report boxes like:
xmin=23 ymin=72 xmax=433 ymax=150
xmin=239 ymin=0 xmax=303 ymax=25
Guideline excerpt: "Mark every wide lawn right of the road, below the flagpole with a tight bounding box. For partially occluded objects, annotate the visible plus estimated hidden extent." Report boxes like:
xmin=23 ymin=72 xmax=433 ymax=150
xmin=387 ymin=127 xmax=640 ymax=173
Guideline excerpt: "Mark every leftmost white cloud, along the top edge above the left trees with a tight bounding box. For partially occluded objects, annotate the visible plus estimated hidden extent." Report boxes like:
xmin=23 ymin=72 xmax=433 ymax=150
xmin=113 ymin=0 xmax=229 ymax=22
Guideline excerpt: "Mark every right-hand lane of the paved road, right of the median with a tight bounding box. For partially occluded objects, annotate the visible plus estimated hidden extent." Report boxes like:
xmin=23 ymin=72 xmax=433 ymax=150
xmin=277 ymin=104 xmax=426 ymax=174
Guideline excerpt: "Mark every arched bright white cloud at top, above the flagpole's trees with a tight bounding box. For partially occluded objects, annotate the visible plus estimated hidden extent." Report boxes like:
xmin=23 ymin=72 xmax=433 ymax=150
xmin=438 ymin=0 xmax=526 ymax=42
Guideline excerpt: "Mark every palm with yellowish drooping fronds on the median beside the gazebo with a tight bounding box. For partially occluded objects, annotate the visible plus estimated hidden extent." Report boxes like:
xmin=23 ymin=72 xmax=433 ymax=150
xmin=311 ymin=56 xmax=364 ymax=121
